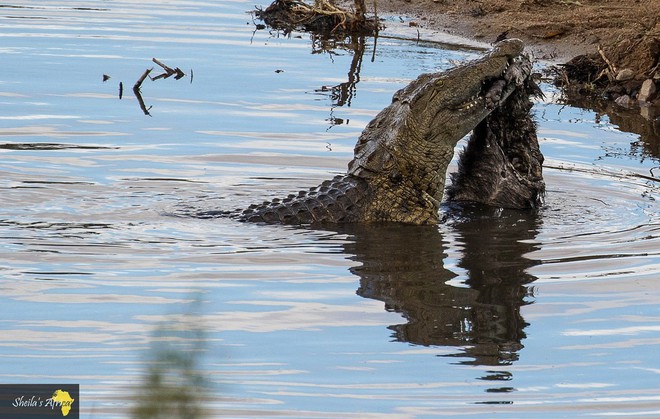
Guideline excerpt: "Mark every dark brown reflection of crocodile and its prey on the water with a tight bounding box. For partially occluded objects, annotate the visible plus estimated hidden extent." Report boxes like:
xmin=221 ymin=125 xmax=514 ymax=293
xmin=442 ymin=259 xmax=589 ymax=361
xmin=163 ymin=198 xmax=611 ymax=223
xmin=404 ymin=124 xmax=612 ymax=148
xmin=336 ymin=209 xmax=538 ymax=365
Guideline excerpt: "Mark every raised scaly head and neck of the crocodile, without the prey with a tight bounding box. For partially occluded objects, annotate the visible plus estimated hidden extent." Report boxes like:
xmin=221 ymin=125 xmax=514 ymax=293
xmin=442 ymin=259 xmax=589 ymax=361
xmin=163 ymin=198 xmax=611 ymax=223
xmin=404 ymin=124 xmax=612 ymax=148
xmin=348 ymin=39 xmax=531 ymax=182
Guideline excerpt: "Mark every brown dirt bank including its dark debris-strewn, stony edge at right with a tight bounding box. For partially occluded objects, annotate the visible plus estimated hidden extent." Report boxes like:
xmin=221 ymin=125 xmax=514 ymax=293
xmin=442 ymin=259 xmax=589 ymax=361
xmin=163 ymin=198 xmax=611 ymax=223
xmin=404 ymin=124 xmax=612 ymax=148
xmin=371 ymin=0 xmax=660 ymax=103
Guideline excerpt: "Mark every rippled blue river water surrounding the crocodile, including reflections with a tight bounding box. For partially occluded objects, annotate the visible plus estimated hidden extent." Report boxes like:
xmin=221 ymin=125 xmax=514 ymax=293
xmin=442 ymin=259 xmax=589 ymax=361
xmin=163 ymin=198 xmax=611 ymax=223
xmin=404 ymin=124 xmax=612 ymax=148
xmin=0 ymin=0 xmax=660 ymax=417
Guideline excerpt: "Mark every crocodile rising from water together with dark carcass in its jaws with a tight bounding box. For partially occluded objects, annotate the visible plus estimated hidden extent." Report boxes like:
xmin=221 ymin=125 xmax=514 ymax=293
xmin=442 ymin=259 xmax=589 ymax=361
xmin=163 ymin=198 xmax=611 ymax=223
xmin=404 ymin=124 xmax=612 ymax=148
xmin=198 ymin=39 xmax=544 ymax=225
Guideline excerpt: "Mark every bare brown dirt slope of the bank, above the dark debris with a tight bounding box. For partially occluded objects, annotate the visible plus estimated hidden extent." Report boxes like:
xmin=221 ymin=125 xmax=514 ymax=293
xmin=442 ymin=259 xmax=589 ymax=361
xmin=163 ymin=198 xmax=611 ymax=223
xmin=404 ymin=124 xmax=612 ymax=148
xmin=371 ymin=0 xmax=660 ymax=61
